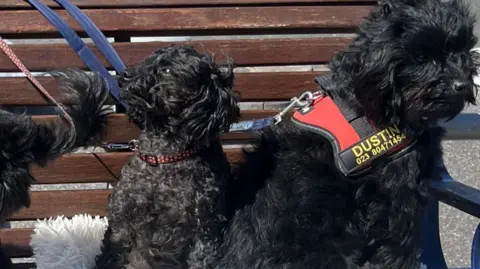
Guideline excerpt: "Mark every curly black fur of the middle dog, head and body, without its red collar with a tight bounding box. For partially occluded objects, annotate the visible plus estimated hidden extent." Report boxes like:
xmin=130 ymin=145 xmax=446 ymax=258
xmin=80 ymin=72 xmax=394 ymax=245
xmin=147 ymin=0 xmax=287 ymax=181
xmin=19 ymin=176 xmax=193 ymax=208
xmin=96 ymin=46 xmax=239 ymax=269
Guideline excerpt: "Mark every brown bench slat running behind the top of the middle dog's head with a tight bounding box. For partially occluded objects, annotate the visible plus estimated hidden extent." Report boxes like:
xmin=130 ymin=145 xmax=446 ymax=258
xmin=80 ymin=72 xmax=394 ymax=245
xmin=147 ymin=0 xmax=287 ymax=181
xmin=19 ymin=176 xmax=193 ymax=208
xmin=0 ymin=38 xmax=351 ymax=72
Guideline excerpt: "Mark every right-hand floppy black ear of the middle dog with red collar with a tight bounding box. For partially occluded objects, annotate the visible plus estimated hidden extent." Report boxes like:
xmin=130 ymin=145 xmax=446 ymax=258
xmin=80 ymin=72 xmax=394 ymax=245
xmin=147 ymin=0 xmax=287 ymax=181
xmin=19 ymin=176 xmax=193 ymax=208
xmin=181 ymin=55 xmax=240 ymax=143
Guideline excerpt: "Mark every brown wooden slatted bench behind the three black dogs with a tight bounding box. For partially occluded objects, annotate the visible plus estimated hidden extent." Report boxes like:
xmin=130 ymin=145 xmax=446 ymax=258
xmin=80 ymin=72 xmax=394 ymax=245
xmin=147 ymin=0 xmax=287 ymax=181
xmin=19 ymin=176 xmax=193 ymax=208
xmin=0 ymin=0 xmax=480 ymax=269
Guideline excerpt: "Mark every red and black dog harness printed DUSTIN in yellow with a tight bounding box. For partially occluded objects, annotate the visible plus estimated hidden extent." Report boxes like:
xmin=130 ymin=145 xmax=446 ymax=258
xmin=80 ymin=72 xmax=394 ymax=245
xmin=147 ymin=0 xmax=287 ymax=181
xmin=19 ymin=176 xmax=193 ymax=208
xmin=292 ymin=76 xmax=415 ymax=176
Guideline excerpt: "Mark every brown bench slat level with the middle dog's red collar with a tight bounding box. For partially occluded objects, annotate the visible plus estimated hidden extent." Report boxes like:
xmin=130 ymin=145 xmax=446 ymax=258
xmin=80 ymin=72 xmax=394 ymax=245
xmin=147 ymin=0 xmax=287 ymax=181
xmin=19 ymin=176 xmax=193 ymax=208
xmin=31 ymin=148 xmax=242 ymax=184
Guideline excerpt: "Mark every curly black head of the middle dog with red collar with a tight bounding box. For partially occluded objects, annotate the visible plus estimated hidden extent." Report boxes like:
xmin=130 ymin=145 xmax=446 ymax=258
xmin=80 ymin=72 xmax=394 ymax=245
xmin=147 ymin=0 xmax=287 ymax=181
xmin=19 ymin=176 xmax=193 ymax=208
xmin=119 ymin=46 xmax=239 ymax=147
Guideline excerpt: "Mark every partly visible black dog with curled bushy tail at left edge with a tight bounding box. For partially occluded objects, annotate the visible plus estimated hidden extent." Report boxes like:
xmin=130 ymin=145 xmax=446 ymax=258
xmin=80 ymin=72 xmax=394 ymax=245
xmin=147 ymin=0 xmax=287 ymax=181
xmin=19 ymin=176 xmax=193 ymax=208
xmin=0 ymin=69 xmax=109 ymax=269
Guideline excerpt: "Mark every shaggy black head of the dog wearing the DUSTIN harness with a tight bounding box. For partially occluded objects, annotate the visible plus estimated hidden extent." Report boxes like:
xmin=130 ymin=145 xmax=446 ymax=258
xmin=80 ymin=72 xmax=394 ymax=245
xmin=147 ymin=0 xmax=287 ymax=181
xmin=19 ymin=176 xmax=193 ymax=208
xmin=331 ymin=0 xmax=479 ymax=129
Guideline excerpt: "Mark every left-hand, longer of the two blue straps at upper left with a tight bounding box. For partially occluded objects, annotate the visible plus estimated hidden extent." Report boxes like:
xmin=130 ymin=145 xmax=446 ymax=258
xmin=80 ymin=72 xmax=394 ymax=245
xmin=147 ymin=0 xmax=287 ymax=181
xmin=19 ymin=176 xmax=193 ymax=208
xmin=27 ymin=0 xmax=128 ymax=108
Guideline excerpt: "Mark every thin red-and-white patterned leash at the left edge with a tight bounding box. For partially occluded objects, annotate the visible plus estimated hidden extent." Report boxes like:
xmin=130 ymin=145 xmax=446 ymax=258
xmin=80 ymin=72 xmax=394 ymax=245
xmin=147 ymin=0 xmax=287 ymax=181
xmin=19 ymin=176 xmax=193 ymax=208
xmin=0 ymin=37 xmax=75 ymax=131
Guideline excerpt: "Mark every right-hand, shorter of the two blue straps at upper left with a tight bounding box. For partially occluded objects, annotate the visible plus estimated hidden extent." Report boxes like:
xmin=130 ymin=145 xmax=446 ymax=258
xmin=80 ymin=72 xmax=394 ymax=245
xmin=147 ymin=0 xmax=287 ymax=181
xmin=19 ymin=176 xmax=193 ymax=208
xmin=54 ymin=0 xmax=125 ymax=73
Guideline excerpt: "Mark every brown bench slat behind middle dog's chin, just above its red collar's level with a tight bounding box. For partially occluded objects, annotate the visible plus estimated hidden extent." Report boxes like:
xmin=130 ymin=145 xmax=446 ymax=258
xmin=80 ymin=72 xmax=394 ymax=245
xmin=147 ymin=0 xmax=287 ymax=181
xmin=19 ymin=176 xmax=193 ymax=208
xmin=33 ymin=110 xmax=277 ymax=143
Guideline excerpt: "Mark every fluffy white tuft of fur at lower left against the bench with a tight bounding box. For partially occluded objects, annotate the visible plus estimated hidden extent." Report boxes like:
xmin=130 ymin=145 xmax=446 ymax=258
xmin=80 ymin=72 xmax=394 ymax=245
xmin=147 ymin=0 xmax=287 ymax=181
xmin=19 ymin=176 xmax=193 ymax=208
xmin=30 ymin=215 xmax=108 ymax=269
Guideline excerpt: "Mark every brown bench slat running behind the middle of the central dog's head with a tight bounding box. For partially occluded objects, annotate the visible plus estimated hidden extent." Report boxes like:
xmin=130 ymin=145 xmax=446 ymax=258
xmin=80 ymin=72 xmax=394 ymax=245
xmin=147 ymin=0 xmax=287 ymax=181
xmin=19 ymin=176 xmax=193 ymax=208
xmin=0 ymin=72 xmax=321 ymax=105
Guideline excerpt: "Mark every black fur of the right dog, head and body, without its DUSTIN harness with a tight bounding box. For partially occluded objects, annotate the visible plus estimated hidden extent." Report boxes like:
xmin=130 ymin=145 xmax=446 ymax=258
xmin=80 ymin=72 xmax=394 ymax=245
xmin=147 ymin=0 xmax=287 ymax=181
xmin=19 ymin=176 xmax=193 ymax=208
xmin=217 ymin=0 xmax=478 ymax=269
